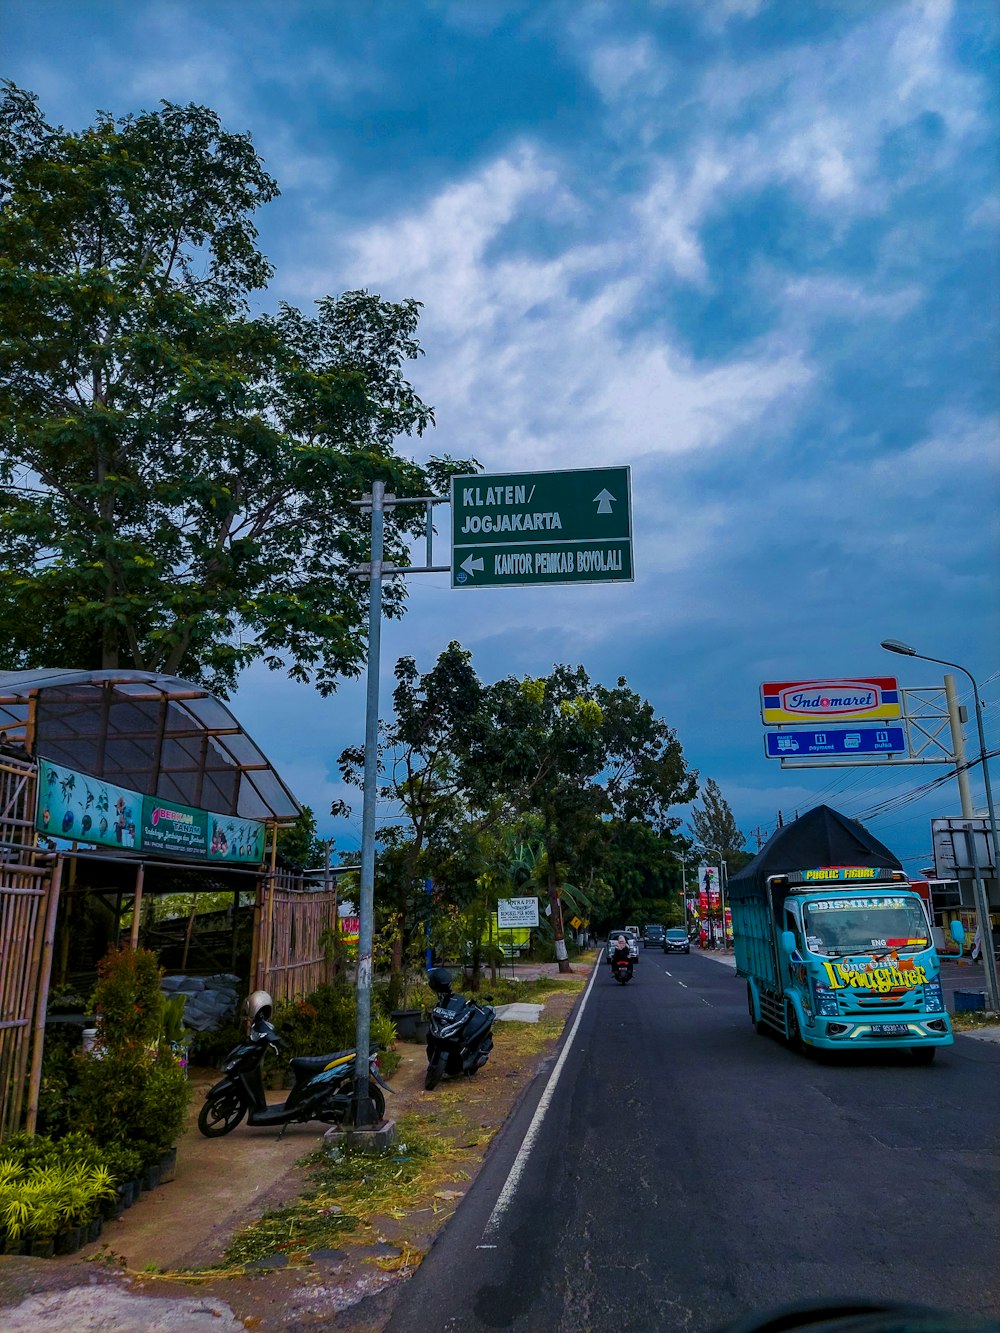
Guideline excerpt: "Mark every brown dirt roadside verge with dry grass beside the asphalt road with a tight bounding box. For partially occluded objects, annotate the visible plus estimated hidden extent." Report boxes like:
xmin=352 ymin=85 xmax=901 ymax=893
xmin=0 ymin=962 xmax=591 ymax=1333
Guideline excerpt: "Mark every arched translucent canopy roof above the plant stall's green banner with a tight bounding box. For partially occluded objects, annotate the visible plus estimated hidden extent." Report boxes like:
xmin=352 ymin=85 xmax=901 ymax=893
xmin=0 ymin=669 xmax=300 ymax=822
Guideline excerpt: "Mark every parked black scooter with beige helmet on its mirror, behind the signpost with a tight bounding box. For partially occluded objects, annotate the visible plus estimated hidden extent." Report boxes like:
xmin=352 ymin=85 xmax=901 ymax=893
xmin=197 ymin=990 xmax=392 ymax=1138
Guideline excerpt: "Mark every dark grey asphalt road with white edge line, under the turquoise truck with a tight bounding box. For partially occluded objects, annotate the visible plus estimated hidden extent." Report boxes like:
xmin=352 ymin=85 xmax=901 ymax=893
xmin=388 ymin=950 xmax=1000 ymax=1333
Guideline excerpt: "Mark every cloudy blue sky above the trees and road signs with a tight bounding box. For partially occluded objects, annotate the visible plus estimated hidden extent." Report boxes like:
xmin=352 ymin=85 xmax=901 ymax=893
xmin=0 ymin=0 xmax=1000 ymax=870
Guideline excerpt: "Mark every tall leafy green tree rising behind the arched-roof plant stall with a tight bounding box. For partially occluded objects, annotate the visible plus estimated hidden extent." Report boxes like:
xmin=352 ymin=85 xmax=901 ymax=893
xmin=0 ymin=83 xmax=475 ymax=693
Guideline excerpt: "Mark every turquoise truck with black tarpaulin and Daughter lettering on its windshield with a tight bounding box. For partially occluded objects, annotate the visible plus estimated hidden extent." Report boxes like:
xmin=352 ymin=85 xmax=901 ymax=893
xmin=728 ymin=805 xmax=953 ymax=1064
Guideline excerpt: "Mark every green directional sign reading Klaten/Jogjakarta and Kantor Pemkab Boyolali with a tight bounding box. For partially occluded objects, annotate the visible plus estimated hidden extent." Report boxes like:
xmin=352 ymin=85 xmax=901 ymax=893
xmin=452 ymin=468 xmax=633 ymax=588
